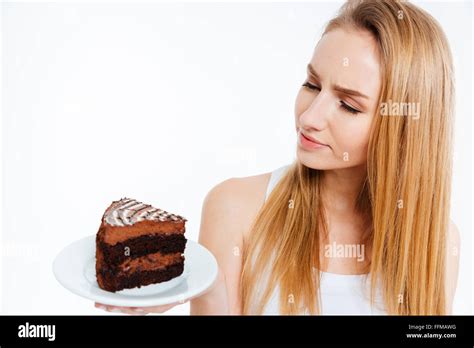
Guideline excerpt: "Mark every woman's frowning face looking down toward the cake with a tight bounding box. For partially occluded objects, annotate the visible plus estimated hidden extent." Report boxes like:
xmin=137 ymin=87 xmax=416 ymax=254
xmin=295 ymin=29 xmax=381 ymax=170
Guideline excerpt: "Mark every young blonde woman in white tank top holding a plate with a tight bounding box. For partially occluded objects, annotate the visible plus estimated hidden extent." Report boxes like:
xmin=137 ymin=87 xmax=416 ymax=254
xmin=97 ymin=1 xmax=459 ymax=315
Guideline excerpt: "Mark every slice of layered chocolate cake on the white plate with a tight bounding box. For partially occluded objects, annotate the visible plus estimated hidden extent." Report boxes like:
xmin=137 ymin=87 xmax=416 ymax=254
xmin=96 ymin=198 xmax=187 ymax=292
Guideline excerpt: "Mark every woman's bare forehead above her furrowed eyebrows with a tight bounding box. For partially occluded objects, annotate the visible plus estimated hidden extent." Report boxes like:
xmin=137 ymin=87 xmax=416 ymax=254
xmin=310 ymin=29 xmax=381 ymax=97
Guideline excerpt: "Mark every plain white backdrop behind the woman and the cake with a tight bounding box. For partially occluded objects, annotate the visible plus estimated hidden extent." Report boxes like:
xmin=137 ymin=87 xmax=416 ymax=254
xmin=0 ymin=1 xmax=473 ymax=314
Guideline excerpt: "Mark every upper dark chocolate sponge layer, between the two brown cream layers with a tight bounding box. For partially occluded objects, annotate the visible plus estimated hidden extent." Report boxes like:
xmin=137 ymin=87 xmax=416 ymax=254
xmin=97 ymin=233 xmax=186 ymax=267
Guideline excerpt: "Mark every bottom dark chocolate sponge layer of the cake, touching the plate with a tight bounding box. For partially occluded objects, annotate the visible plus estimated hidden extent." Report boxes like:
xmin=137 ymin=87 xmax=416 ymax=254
xmin=97 ymin=263 xmax=184 ymax=292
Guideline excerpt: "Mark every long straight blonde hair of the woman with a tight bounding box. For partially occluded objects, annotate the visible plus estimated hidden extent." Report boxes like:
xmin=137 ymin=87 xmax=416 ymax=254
xmin=240 ymin=1 xmax=454 ymax=315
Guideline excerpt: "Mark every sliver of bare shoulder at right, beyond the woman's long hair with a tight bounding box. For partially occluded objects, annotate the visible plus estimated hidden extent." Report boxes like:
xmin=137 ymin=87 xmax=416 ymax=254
xmin=446 ymin=221 xmax=461 ymax=314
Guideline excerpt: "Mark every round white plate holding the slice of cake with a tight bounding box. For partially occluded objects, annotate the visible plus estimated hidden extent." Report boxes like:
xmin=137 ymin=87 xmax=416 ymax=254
xmin=53 ymin=235 xmax=217 ymax=307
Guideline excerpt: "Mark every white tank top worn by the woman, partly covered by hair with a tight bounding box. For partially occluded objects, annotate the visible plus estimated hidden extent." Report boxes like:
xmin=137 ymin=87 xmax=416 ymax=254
xmin=259 ymin=165 xmax=386 ymax=315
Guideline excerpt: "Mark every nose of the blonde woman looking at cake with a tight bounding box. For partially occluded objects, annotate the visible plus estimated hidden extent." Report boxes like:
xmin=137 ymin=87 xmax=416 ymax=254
xmin=299 ymin=92 xmax=331 ymax=131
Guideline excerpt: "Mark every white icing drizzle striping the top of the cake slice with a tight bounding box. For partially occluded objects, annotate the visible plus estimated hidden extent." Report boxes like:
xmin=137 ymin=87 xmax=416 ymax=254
xmin=102 ymin=198 xmax=187 ymax=226
